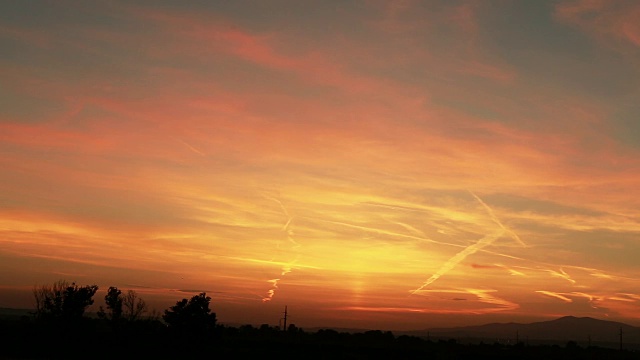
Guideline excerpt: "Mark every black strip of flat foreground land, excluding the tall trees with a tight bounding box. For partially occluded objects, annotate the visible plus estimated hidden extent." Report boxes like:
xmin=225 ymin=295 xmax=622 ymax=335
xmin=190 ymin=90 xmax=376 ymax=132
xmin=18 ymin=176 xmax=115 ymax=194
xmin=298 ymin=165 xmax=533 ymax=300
xmin=0 ymin=315 xmax=640 ymax=360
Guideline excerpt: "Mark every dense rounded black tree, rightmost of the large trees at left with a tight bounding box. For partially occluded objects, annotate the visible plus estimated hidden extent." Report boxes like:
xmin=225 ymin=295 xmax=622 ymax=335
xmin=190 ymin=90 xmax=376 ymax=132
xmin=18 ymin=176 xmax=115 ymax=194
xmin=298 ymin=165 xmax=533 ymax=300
xmin=162 ymin=293 xmax=216 ymax=334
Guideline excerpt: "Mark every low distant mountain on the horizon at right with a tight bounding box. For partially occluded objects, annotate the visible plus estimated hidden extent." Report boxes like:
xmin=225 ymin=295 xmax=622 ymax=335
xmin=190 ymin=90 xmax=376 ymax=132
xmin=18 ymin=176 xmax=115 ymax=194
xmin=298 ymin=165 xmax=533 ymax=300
xmin=404 ymin=316 xmax=640 ymax=345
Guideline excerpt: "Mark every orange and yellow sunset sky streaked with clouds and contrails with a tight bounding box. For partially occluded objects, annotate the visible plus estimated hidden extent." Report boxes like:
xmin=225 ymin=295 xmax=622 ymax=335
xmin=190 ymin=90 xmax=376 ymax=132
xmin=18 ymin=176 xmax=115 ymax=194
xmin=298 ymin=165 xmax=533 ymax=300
xmin=0 ymin=0 xmax=640 ymax=330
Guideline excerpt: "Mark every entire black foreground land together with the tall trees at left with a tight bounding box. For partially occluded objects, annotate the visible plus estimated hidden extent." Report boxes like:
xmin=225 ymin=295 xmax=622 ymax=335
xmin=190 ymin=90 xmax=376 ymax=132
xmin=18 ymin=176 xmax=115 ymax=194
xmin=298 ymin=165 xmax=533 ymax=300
xmin=0 ymin=281 xmax=640 ymax=360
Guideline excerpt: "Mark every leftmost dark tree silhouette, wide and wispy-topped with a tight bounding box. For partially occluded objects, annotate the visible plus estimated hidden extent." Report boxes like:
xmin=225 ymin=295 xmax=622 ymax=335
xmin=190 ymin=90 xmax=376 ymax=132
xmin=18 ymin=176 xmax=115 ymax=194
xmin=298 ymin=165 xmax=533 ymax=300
xmin=33 ymin=280 xmax=98 ymax=321
